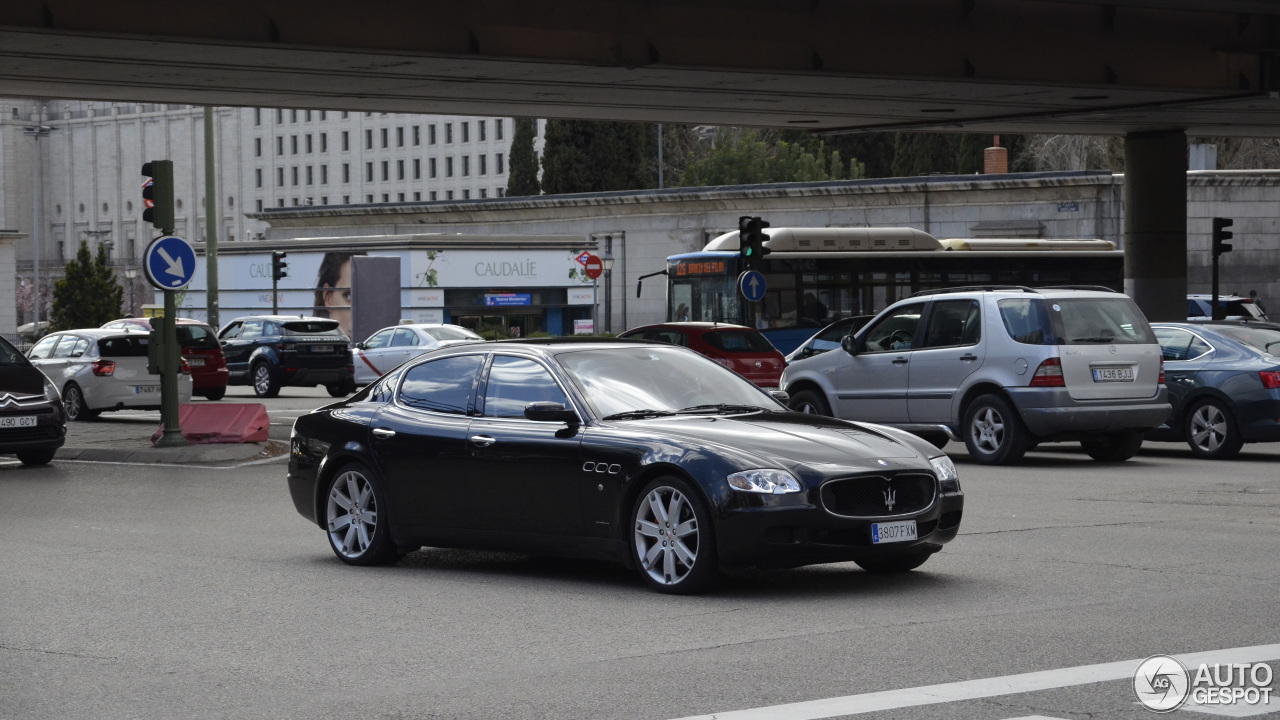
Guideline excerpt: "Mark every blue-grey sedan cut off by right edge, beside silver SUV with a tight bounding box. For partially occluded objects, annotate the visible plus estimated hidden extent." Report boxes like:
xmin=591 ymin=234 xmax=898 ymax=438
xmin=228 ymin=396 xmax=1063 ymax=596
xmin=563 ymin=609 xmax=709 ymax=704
xmin=1147 ymin=322 xmax=1280 ymax=460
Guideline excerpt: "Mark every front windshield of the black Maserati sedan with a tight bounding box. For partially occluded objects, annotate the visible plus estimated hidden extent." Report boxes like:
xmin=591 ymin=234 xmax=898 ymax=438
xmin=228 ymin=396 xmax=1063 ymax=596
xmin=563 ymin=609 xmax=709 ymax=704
xmin=556 ymin=346 xmax=786 ymax=418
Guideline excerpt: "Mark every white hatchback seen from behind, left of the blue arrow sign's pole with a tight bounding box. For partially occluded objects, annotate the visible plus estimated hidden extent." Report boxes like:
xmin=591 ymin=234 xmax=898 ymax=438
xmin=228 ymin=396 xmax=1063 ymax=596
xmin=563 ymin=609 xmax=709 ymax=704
xmin=27 ymin=329 xmax=191 ymax=420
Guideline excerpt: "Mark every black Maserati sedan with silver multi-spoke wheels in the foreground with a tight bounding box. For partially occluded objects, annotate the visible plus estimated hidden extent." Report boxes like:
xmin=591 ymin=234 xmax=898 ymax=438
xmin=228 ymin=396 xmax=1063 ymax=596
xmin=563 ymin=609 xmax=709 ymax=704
xmin=288 ymin=338 xmax=964 ymax=593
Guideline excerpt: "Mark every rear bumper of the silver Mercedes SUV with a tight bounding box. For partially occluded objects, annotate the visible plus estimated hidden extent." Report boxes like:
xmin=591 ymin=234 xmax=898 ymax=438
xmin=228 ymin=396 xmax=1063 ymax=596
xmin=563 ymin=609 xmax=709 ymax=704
xmin=1006 ymin=386 xmax=1172 ymax=438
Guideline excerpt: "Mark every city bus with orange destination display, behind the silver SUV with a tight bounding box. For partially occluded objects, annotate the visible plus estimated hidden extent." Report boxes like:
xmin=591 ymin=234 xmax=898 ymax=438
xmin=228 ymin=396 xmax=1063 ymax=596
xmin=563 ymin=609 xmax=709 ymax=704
xmin=650 ymin=228 xmax=1124 ymax=354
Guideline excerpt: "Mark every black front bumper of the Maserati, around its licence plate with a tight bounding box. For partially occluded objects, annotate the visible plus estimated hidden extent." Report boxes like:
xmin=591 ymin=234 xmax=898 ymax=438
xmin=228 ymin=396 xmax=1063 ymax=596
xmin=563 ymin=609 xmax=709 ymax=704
xmin=716 ymin=492 xmax=964 ymax=570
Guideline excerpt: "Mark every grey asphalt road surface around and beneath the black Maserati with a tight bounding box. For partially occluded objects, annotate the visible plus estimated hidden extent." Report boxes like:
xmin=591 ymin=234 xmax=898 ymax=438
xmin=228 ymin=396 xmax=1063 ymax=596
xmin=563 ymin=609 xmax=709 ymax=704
xmin=0 ymin=427 xmax=1280 ymax=720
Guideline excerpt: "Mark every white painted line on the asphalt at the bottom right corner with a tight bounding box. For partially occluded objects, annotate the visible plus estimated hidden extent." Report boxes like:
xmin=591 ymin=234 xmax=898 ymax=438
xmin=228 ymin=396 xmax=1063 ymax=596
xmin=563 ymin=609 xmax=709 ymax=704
xmin=680 ymin=643 xmax=1280 ymax=720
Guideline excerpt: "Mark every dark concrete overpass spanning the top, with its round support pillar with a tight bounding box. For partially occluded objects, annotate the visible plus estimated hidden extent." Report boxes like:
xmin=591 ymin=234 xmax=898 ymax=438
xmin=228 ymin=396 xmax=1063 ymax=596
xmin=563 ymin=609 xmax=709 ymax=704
xmin=0 ymin=0 xmax=1280 ymax=319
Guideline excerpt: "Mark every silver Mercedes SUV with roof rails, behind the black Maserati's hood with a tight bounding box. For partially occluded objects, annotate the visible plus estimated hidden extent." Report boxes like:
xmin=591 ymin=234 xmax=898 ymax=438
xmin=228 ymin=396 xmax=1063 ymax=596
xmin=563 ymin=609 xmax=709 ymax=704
xmin=780 ymin=287 xmax=1170 ymax=465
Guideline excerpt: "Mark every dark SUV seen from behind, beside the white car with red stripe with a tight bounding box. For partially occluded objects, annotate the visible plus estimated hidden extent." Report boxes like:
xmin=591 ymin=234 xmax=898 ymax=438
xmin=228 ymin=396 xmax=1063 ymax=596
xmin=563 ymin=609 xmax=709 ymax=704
xmin=218 ymin=315 xmax=356 ymax=397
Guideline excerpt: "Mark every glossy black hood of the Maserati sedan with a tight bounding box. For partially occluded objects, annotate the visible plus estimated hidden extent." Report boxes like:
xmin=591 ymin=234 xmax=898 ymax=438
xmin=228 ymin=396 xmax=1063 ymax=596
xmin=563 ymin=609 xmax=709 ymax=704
xmin=627 ymin=413 xmax=929 ymax=470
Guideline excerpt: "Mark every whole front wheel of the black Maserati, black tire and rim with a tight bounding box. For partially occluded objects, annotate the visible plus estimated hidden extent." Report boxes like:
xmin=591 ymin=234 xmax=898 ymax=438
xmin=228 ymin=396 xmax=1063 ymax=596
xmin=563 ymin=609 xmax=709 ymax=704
xmin=628 ymin=477 xmax=719 ymax=594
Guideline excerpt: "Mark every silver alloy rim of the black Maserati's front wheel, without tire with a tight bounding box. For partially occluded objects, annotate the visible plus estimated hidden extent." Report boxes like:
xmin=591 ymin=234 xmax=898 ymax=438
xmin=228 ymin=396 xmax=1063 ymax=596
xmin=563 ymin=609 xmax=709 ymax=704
xmin=635 ymin=486 xmax=700 ymax=585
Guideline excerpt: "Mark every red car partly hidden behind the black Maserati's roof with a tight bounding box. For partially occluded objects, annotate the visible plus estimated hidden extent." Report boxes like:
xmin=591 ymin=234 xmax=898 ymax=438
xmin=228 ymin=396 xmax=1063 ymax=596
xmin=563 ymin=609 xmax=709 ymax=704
xmin=618 ymin=323 xmax=787 ymax=388
